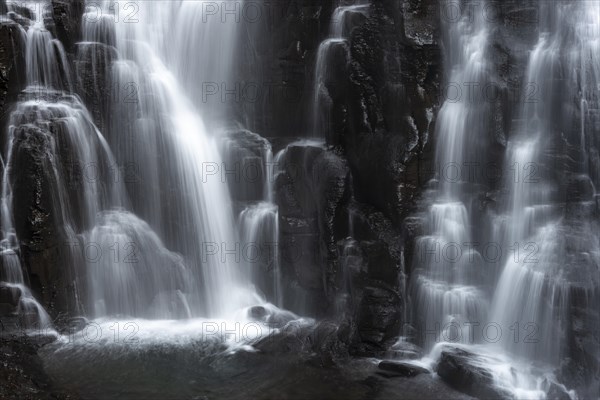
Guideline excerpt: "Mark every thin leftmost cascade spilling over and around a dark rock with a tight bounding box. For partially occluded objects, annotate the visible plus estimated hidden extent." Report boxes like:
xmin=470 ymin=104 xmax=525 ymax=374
xmin=1 ymin=2 xmax=101 ymax=332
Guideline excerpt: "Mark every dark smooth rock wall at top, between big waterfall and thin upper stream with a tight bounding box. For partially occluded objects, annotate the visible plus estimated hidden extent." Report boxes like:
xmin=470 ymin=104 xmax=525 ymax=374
xmin=237 ymin=0 xmax=335 ymax=137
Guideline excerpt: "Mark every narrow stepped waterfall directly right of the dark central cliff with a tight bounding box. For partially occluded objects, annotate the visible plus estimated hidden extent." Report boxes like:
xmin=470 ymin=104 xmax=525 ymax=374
xmin=411 ymin=0 xmax=489 ymax=349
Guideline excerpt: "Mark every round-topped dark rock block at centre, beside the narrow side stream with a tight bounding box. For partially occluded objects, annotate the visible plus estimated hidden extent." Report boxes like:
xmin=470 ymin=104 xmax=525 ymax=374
xmin=274 ymin=145 xmax=348 ymax=315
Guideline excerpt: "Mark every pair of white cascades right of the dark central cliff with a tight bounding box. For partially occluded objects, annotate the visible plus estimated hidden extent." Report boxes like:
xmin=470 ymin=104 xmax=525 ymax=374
xmin=411 ymin=2 xmax=600 ymax=398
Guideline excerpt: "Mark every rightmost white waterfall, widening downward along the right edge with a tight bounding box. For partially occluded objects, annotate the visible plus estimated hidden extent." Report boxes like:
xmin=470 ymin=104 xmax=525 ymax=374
xmin=490 ymin=2 xmax=600 ymax=365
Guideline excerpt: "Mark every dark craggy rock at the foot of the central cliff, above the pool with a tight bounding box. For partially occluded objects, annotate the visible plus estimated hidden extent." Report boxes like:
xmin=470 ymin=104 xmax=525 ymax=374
xmin=338 ymin=202 xmax=407 ymax=355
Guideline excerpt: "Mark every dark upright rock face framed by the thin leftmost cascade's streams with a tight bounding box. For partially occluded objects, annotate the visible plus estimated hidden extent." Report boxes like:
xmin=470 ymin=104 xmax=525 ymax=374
xmin=11 ymin=120 xmax=76 ymax=315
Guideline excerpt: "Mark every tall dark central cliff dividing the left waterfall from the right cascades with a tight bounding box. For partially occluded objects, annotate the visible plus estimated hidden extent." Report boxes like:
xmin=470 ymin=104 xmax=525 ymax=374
xmin=262 ymin=0 xmax=441 ymax=354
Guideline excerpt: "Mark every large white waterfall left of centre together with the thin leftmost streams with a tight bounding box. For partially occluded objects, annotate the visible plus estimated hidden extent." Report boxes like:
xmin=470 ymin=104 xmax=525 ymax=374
xmin=2 ymin=1 xmax=268 ymax=324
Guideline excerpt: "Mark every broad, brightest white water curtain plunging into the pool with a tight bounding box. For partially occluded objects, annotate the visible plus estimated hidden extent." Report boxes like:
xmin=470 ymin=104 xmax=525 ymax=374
xmin=84 ymin=1 xmax=255 ymax=318
